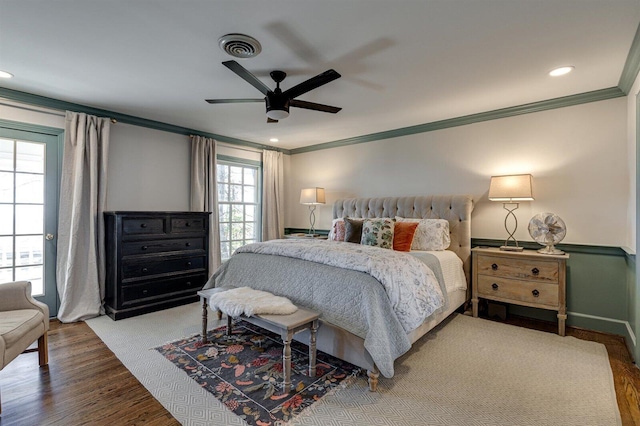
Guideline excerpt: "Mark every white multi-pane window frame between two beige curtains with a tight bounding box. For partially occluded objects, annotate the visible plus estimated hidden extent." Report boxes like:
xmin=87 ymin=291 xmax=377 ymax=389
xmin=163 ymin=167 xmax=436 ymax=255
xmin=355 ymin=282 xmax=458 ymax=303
xmin=216 ymin=155 xmax=262 ymax=262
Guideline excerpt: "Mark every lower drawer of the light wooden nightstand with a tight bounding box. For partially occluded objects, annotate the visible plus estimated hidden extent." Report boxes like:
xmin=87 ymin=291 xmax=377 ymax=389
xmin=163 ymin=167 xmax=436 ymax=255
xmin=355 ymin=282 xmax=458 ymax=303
xmin=478 ymin=276 xmax=559 ymax=307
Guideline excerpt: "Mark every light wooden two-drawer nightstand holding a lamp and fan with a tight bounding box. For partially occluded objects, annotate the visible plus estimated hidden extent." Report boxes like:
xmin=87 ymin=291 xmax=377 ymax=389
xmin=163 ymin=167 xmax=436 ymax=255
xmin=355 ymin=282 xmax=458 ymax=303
xmin=471 ymin=248 xmax=569 ymax=336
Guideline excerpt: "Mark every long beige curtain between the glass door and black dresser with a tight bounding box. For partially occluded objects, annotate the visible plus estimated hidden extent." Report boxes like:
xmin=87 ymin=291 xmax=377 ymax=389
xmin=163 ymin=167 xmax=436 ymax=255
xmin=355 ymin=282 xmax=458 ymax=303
xmin=56 ymin=111 xmax=111 ymax=322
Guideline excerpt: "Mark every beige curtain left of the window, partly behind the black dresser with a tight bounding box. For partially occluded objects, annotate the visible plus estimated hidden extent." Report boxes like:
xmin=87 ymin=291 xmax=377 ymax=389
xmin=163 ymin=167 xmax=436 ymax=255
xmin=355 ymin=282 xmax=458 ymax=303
xmin=190 ymin=136 xmax=222 ymax=275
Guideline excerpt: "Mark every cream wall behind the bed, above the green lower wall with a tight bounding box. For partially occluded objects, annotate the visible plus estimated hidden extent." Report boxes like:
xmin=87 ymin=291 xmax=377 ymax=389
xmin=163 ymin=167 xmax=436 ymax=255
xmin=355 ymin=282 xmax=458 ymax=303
xmin=285 ymin=98 xmax=630 ymax=246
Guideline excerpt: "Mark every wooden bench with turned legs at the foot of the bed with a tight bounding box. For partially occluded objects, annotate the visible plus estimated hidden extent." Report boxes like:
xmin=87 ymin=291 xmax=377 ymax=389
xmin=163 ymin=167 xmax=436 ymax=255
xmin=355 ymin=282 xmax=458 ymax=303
xmin=198 ymin=288 xmax=320 ymax=392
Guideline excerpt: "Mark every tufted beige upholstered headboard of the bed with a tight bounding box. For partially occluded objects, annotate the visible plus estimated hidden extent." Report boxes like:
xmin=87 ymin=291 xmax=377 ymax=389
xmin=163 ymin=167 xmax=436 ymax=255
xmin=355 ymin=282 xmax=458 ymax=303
xmin=333 ymin=195 xmax=473 ymax=283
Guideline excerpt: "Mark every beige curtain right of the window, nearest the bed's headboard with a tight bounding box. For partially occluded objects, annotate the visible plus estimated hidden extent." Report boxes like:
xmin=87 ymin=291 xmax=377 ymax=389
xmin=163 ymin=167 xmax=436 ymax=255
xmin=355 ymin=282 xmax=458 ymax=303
xmin=262 ymin=150 xmax=284 ymax=241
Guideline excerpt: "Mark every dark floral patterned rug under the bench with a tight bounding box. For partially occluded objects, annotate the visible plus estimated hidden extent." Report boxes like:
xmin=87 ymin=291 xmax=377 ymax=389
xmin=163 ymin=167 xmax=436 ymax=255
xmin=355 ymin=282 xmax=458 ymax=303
xmin=156 ymin=321 xmax=360 ymax=426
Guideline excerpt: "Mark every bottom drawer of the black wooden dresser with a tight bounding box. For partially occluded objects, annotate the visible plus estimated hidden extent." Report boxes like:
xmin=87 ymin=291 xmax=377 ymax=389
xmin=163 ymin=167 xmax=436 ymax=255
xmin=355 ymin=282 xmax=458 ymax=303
xmin=122 ymin=275 xmax=207 ymax=306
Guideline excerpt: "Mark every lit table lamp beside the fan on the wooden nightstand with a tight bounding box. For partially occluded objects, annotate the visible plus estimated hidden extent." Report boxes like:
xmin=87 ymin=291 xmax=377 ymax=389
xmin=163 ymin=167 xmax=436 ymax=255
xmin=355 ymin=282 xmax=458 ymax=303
xmin=489 ymin=175 xmax=533 ymax=251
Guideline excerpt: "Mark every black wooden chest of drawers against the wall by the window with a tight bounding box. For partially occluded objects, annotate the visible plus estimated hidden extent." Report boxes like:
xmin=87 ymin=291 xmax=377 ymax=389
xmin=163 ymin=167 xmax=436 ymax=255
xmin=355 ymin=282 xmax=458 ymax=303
xmin=104 ymin=211 xmax=210 ymax=320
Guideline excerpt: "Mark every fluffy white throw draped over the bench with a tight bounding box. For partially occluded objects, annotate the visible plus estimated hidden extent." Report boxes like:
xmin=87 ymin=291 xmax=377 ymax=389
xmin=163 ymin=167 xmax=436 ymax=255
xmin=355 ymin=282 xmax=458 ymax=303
xmin=209 ymin=287 xmax=298 ymax=317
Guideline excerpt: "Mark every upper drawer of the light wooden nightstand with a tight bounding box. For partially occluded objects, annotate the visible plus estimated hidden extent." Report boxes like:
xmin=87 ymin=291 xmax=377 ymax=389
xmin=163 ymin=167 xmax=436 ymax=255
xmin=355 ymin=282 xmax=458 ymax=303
xmin=476 ymin=255 xmax=559 ymax=283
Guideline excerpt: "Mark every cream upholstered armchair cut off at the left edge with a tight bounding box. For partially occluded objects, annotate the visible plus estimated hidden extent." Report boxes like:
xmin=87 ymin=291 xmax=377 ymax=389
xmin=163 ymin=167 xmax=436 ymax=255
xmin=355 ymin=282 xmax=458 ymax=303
xmin=0 ymin=281 xmax=49 ymax=413
